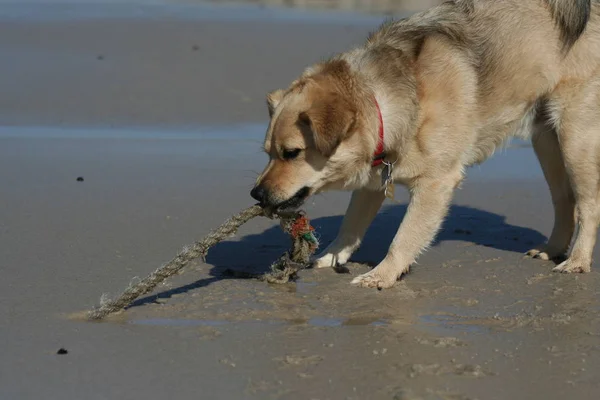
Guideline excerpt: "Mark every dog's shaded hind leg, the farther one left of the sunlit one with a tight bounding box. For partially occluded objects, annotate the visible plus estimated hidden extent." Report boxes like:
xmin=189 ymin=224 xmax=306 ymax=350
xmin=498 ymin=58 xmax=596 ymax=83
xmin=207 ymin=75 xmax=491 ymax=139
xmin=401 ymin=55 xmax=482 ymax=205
xmin=527 ymin=114 xmax=575 ymax=260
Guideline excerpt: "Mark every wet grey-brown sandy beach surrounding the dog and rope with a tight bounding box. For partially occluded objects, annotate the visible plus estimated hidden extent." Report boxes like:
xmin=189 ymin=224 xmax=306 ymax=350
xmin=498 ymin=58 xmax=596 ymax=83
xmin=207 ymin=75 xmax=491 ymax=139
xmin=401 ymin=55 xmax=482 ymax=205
xmin=0 ymin=0 xmax=600 ymax=400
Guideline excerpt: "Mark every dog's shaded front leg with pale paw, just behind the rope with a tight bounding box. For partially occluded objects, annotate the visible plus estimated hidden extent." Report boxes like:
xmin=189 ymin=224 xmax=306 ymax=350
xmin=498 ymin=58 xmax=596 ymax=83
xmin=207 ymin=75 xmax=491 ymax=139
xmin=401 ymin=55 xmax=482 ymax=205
xmin=313 ymin=189 xmax=385 ymax=268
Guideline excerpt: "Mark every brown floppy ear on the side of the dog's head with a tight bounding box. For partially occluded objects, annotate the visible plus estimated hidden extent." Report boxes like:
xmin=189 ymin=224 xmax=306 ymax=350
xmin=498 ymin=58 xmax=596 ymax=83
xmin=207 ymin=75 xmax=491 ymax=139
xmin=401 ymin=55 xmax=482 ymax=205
xmin=299 ymin=95 xmax=356 ymax=157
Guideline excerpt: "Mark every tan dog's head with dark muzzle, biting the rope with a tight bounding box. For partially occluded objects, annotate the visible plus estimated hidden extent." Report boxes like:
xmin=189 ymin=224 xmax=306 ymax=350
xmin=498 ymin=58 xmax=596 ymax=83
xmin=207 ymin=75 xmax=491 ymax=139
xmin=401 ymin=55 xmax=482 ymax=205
xmin=251 ymin=61 xmax=372 ymax=211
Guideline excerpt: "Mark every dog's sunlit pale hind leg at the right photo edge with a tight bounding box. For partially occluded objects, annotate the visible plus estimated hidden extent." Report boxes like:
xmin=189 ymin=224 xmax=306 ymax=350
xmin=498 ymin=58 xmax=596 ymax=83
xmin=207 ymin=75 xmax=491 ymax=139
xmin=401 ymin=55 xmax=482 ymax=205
xmin=551 ymin=77 xmax=600 ymax=273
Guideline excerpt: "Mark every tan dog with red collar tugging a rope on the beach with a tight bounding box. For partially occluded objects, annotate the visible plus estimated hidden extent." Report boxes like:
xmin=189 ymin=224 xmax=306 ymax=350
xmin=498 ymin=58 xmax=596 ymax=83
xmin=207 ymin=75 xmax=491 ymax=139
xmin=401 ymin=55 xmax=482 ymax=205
xmin=250 ymin=0 xmax=600 ymax=289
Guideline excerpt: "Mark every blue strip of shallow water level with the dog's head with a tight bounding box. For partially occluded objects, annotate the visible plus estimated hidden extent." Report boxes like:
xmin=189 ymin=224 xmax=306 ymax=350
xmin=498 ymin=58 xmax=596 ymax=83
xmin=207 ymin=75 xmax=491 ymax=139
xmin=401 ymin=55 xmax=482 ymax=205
xmin=0 ymin=122 xmax=543 ymax=181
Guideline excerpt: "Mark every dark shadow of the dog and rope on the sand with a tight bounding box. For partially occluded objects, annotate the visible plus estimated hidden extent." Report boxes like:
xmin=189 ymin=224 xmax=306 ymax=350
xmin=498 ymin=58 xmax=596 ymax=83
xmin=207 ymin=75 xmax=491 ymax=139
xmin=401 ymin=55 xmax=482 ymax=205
xmin=129 ymin=205 xmax=546 ymax=308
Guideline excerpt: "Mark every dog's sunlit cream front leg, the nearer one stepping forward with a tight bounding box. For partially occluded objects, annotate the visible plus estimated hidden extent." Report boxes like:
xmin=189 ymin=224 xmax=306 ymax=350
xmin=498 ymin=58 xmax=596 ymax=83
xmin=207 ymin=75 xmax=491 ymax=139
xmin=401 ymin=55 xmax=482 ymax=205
xmin=352 ymin=173 xmax=462 ymax=289
